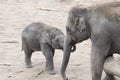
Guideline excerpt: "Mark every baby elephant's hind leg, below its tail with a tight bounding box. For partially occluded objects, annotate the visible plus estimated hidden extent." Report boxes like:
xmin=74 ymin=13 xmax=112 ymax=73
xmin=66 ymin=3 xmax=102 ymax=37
xmin=22 ymin=41 xmax=33 ymax=68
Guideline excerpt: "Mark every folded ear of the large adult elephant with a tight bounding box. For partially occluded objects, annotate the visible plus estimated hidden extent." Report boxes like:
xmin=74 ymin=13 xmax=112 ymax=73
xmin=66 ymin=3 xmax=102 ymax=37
xmin=75 ymin=16 xmax=86 ymax=32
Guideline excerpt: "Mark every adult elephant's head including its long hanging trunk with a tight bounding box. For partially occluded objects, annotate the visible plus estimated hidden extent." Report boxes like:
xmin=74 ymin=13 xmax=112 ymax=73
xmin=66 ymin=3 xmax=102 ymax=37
xmin=61 ymin=8 xmax=90 ymax=80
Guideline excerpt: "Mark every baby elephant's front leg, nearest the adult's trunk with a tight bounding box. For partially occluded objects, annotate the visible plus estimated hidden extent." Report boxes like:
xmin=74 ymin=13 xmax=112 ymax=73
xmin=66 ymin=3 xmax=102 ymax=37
xmin=41 ymin=43 xmax=55 ymax=75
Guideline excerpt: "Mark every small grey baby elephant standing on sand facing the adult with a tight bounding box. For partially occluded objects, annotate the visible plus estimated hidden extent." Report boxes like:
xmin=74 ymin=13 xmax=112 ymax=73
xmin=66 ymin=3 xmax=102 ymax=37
xmin=22 ymin=22 xmax=75 ymax=75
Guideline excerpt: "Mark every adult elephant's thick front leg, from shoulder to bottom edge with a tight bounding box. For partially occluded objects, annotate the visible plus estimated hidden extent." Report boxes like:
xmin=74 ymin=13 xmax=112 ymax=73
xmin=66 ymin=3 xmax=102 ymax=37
xmin=91 ymin=33 xmax=111 ymax=80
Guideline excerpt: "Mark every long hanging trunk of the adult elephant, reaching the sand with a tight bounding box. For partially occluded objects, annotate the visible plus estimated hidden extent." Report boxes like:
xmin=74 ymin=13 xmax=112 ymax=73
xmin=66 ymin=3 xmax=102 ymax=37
xmin=61 ymin=36 xmax=73 ymax=80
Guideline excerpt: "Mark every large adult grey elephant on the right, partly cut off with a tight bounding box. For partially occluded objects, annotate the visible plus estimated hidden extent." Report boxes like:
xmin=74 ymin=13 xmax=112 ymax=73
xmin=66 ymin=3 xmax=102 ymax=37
xmin=61 ymin=2 xmax=120 ymax=80
